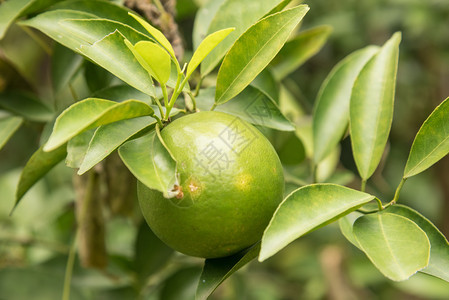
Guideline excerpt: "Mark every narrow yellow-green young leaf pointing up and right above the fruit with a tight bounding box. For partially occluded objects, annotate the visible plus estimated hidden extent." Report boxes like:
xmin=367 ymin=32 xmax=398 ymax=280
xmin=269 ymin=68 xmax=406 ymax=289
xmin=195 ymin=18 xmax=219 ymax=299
xmin=186 ymin=28 xmax=235 ymax=78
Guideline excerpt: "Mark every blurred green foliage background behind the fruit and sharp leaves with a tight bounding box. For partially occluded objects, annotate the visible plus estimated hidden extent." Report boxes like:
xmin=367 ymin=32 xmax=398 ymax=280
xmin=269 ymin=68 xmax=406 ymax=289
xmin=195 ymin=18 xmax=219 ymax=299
xmin=0 ymin=0 xmax=449 ymax=300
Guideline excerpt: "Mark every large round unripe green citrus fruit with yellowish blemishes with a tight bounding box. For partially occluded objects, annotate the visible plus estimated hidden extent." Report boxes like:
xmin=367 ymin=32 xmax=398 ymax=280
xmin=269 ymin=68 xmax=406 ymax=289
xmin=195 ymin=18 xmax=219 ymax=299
xmin=138 ymin=111 xmax=284 ymax=258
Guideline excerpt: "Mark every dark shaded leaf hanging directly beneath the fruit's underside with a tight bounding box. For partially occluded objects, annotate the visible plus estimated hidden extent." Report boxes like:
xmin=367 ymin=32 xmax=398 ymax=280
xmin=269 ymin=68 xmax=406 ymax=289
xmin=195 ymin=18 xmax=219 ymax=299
xmin=195 ymin=242 xmax=260 ymax=300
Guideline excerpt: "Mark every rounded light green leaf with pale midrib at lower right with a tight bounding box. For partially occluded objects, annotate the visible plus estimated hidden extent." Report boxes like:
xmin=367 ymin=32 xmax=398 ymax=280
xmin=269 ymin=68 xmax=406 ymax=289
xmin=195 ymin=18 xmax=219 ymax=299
xmin=353 ymin=213 xmax=430 ymax=281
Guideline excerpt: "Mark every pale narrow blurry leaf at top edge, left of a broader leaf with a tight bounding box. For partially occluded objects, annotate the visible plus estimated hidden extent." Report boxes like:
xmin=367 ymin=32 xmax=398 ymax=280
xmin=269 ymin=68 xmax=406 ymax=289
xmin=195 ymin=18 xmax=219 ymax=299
xmin=192 ymin=0 xmax=225 ymax=49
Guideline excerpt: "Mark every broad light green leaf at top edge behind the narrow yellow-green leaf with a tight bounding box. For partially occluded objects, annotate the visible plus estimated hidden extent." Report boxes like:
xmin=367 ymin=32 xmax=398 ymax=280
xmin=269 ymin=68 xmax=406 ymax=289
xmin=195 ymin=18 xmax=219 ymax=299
xmin=201 ymin=0 xmax=281 ymax=77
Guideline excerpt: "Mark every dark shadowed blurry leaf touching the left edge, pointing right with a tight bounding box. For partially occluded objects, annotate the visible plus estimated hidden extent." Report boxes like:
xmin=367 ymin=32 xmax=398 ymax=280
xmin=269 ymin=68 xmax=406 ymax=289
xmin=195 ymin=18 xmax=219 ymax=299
xmin=0 ymin=92 xmax=54 ymax=122
